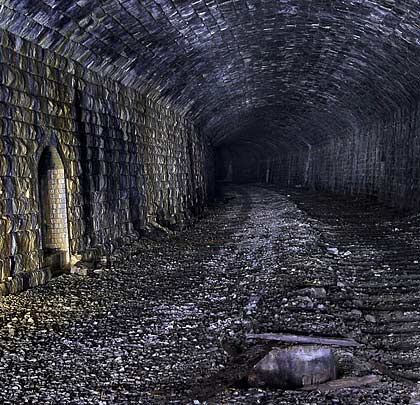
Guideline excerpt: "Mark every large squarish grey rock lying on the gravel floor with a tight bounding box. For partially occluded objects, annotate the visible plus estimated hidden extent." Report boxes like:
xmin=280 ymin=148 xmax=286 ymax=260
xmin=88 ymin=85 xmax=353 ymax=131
xmin=248 ymin=346 xmax=336 ymax=389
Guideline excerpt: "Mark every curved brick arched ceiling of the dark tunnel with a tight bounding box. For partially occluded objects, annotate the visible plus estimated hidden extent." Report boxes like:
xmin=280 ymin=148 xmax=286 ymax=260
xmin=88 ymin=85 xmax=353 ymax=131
xmin=0 ymin=0 xmax=420 ymax=145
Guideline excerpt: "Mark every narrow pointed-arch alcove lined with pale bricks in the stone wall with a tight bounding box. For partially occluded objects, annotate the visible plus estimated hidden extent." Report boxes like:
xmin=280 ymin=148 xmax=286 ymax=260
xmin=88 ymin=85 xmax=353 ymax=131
xmin=38 ymin=146 xmax=69 ymax=270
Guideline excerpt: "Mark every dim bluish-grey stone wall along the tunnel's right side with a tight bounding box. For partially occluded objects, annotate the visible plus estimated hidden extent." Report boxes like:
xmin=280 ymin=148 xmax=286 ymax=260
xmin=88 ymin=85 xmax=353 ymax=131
xmin=274 ymin=102 xmax=420 ymax=209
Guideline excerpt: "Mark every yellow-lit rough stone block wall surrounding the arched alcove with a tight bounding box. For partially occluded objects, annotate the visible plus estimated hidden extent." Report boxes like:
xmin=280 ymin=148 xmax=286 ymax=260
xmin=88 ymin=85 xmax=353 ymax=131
xmin=0 ymin=31 xmax=211 ymax=292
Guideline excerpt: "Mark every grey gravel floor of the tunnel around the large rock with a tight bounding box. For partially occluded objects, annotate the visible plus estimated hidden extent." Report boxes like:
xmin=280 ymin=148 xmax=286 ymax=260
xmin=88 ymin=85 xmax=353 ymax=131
xmin=0 ymin=186 xmax=420 ymax=405
